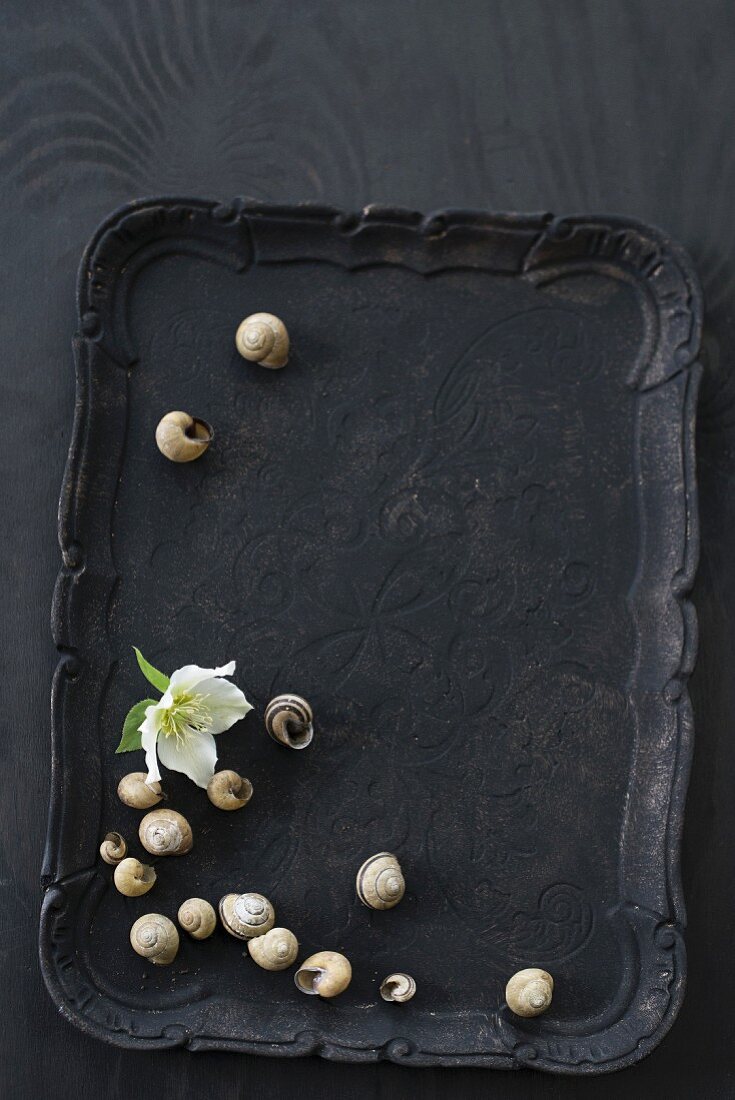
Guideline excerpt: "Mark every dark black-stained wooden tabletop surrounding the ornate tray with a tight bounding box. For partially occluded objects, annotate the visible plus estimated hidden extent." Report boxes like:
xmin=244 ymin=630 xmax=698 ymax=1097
xmin=0 ymin=0 xmax=735 ymax=1100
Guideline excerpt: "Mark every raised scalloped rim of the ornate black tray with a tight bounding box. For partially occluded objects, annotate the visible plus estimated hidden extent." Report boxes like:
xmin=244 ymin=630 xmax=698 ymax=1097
xmin=40 ymin=198 xmax=702 ymax=1075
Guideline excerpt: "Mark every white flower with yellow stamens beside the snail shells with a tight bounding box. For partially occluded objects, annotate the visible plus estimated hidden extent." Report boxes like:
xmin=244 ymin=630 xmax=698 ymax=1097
xmin=139 ymin=661 xmax=252 ymax=787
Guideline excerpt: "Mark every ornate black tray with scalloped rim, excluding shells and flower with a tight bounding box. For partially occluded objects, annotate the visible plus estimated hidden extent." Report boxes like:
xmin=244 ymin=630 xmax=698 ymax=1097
xmin=41 ymin=199 xmax=701 ymax=1074
